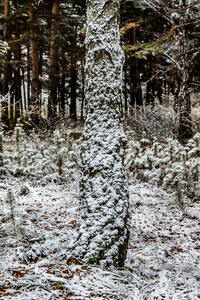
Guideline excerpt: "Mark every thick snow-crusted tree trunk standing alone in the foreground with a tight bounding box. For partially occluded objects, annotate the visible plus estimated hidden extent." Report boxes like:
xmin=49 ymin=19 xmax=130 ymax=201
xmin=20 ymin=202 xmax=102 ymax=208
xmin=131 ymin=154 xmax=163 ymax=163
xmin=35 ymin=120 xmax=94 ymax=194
xmin=68 ymin=0 xmax=130 ymax=267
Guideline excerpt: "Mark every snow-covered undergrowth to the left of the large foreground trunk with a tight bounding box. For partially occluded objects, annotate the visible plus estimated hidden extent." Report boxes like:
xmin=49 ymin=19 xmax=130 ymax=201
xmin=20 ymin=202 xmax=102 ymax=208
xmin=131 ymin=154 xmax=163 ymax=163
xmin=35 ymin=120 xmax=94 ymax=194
xmin=0 ymin=126 xmax=79 ymax=182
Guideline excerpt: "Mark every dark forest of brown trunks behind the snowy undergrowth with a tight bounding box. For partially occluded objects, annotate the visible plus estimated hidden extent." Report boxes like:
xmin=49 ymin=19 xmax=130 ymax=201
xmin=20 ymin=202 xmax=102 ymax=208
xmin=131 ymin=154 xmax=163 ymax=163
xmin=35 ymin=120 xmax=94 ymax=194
xmin=0 ymin=0 xmax=200 ymax=141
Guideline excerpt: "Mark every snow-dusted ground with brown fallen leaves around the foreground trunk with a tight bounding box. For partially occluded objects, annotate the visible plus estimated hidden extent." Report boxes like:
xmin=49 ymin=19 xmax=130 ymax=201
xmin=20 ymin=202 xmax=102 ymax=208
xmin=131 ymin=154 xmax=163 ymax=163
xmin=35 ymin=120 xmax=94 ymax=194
xmin=0 ymin=178 xmax=200 ymax=300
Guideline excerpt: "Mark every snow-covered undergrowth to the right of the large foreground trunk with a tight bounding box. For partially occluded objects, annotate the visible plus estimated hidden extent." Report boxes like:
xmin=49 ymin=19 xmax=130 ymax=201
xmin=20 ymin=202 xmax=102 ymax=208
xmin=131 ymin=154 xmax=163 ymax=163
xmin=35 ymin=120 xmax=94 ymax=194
xmin=126 ymin=133 xmax=200 ymax=204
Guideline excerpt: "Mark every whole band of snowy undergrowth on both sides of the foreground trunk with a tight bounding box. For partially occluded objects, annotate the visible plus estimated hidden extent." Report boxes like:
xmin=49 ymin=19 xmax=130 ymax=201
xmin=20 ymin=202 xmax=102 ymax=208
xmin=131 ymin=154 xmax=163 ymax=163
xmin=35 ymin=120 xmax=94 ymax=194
xmin=0 ymin=118 xmax=200 ymax=208
